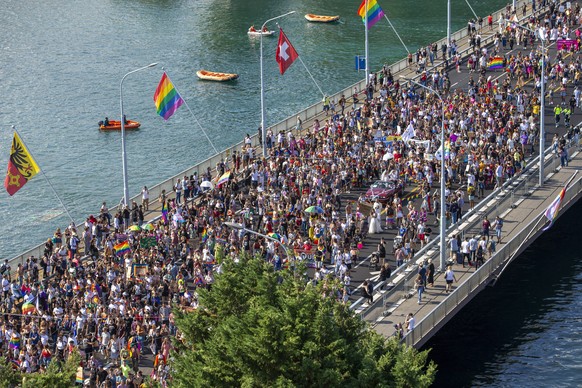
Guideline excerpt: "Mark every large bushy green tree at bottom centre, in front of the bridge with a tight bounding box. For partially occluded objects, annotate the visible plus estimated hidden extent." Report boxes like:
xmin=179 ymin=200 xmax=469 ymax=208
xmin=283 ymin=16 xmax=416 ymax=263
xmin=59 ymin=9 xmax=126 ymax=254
xmin=171 ymin=257 xmax=436 ymax=387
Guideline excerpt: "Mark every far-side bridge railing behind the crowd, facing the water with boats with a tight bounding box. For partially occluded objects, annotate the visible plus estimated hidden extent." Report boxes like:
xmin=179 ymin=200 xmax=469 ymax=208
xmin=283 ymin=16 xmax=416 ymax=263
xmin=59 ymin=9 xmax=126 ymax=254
xmin=4 ymin=0 xmax=540 ymax=278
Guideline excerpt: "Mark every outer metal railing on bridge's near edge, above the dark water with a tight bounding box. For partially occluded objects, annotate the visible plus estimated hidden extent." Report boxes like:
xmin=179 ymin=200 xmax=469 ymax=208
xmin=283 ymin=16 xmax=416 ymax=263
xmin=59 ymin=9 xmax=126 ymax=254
xmin=403 ymin=151 xmax=582 ymax=346
